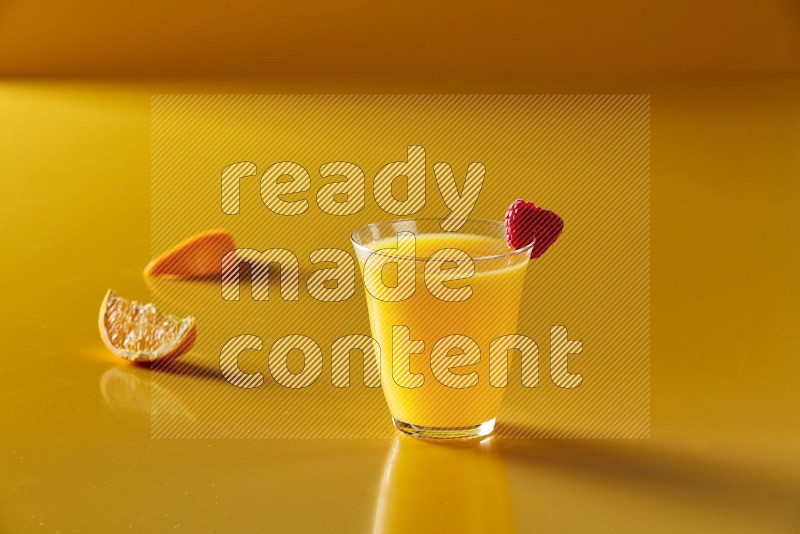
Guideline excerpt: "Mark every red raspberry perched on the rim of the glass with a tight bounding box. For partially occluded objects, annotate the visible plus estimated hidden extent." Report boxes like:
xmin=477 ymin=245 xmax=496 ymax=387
xmin=506 ymin=200 xmax=564 ymax=258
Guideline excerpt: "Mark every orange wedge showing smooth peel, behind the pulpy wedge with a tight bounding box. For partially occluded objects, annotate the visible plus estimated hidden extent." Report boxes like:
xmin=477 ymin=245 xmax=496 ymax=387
xmin=144 ymin=230 xmax=236 ymax=280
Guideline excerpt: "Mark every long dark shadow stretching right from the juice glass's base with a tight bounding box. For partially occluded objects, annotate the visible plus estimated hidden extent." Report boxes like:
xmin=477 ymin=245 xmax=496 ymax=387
xmin=498 ymin=424 xmax=800 ymax=528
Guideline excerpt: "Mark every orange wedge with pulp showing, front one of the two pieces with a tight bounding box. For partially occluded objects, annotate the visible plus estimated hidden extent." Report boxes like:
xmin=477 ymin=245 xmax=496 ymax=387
xmin=98 ymin=289 xmax=196 ymax=362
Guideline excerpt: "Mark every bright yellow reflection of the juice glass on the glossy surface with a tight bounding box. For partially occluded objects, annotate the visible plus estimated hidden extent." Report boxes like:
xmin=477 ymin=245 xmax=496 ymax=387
xmin=373 ymin=436 xmax=514 ymax=533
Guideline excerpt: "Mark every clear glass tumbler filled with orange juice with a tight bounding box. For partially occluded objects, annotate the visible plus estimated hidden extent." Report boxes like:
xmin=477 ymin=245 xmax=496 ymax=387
xmin=351 ymin=219 xmax=533 ymax=439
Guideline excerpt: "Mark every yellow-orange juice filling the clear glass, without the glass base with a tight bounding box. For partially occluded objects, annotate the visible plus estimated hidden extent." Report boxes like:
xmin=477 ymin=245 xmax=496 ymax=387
xmin=360 ymin=233 xmax=528 ymax=428
